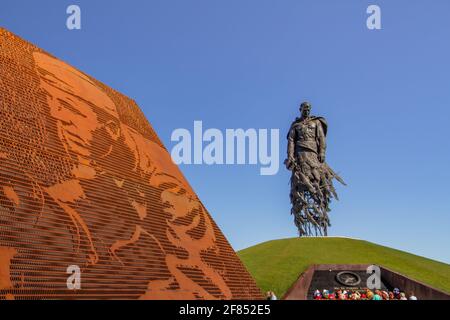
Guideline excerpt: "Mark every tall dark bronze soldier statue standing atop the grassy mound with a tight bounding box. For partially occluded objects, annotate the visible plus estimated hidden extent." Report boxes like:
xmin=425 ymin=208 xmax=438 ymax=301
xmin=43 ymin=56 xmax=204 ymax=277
xmin=285 ymin=102 xmax=345 ymax=237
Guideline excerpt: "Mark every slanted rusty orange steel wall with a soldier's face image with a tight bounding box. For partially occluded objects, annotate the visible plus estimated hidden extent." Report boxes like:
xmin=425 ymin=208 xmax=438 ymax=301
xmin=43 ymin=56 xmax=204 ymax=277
xmin=0 ymin=29 xmax=261 ymax=299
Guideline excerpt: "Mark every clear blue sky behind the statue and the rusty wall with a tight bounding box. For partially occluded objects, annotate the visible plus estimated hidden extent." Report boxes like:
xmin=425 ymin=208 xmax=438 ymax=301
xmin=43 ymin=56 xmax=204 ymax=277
xmin=0 ymin=0 xmax=450 ymax=263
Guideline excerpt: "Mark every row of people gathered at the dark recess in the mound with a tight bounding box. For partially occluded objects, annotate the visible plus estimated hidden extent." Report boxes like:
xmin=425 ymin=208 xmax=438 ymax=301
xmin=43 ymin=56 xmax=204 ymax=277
xmin=314 ymin=288 xmax=417 ymax=300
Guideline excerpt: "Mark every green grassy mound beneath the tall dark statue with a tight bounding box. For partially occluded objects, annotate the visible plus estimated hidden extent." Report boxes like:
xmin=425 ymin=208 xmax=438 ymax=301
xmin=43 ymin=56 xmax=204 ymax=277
xmin=238 ymin=237 xmax=450 ymax=297
